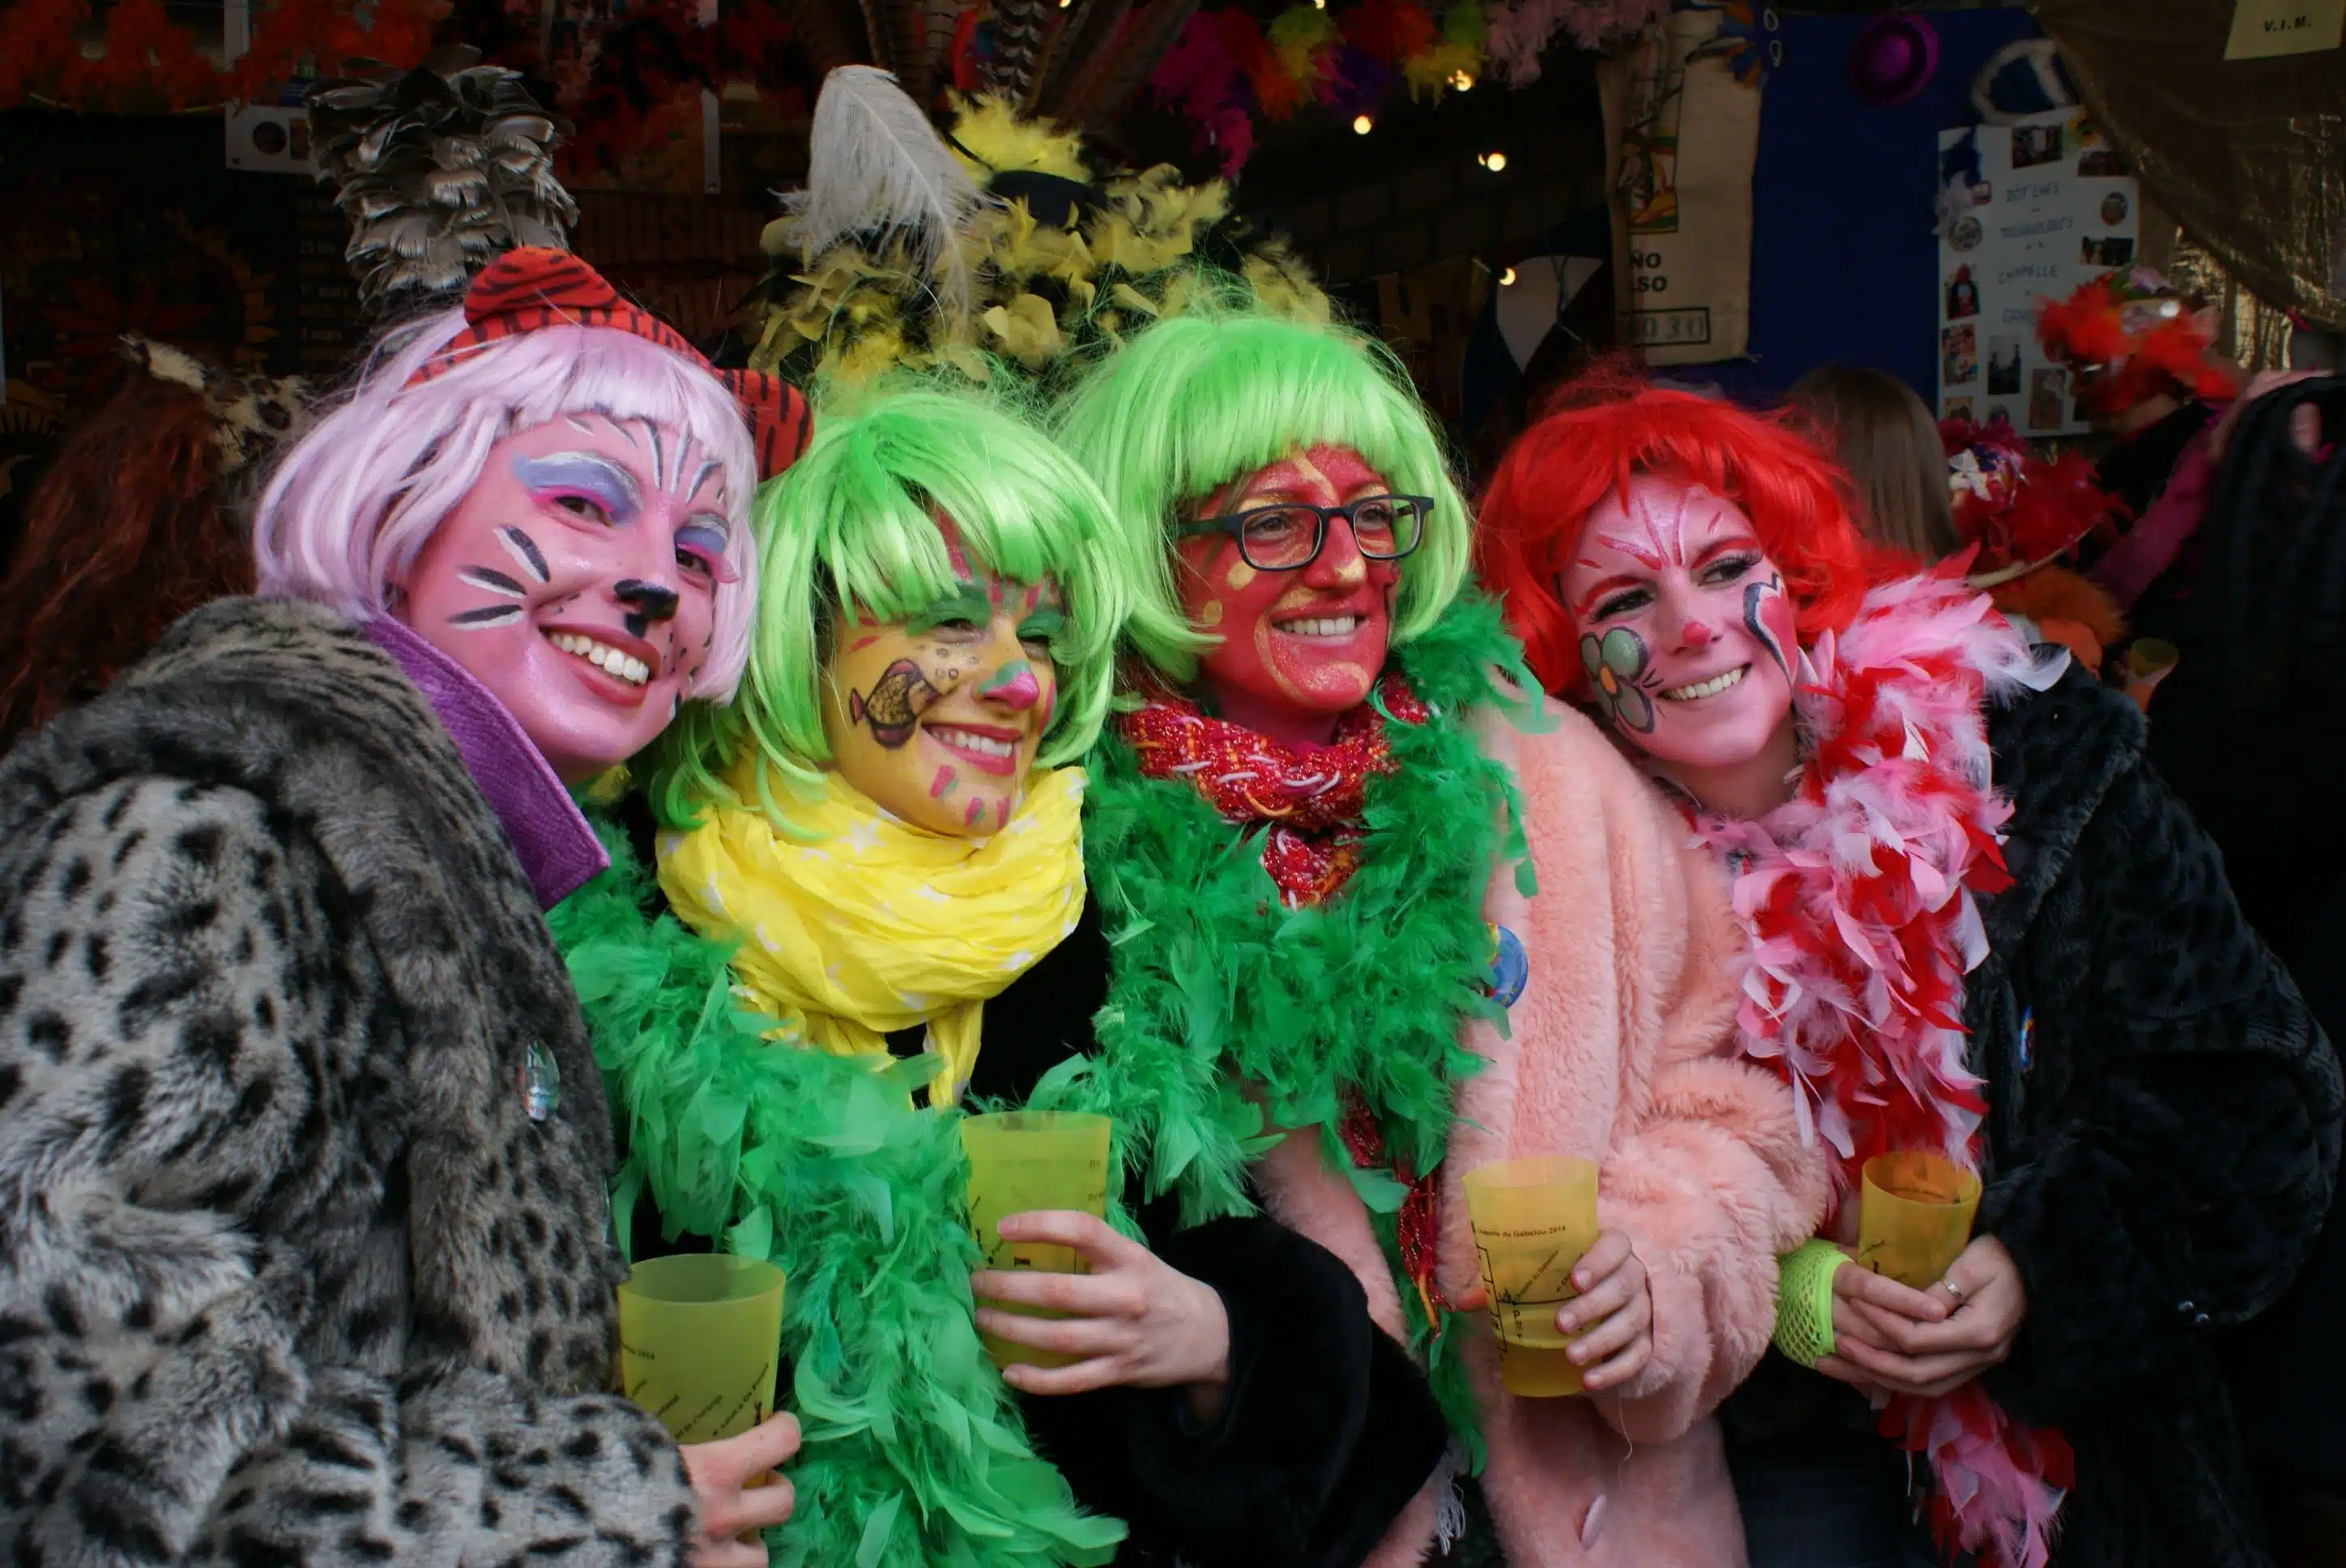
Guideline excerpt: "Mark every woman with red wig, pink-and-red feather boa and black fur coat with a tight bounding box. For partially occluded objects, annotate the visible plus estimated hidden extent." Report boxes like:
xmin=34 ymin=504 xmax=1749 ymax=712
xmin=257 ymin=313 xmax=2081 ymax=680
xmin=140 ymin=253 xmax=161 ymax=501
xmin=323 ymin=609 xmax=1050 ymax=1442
xmin=1478 ymin=377 xmax=2341 ymax=1568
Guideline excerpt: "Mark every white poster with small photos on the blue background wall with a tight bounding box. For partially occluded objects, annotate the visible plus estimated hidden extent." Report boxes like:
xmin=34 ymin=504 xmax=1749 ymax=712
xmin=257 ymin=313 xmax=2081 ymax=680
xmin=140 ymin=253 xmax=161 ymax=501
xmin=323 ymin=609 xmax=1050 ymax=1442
xmin=1935 ymin=110 xmax=2137 ymax=438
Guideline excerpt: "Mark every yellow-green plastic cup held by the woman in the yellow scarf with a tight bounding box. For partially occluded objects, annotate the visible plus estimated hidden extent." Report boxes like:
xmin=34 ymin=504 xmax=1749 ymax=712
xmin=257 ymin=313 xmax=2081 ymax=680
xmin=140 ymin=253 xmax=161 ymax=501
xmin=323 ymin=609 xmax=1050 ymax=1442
xmin=962 ymin=1111 xmax=1115 ymax=1366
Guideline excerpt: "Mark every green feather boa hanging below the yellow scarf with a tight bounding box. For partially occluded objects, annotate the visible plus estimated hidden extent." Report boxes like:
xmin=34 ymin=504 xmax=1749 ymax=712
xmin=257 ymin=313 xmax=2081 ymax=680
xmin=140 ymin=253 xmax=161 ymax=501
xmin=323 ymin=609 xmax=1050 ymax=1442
xmin=549 ymin=823 xmax=1124 ymax=1568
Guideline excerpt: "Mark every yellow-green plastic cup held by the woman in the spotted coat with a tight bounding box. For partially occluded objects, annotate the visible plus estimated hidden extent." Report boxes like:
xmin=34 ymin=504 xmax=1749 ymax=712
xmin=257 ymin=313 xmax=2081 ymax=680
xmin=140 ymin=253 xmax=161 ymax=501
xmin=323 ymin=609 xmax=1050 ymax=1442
xmin=620 ymin=1251 xmax=783 ymax=1444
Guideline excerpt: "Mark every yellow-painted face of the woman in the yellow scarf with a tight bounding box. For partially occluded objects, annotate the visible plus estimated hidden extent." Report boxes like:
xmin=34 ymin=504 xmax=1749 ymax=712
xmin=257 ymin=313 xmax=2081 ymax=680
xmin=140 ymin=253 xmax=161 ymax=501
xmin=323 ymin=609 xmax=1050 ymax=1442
xmin=823 ymin=513 xmax=1068 ymax=837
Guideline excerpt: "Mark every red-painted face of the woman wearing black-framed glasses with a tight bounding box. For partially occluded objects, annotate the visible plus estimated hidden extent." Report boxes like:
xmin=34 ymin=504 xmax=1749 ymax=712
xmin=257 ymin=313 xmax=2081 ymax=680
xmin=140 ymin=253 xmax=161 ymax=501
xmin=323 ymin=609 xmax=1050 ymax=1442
xmin=1173 ymin=448 xmax=1401 ymax=743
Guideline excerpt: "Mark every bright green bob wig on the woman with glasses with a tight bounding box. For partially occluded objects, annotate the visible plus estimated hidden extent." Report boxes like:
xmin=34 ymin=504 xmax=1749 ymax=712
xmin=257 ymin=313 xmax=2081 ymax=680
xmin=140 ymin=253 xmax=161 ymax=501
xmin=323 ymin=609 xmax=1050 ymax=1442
xmin=1058 ymin=305 xmax=1469 ymax=682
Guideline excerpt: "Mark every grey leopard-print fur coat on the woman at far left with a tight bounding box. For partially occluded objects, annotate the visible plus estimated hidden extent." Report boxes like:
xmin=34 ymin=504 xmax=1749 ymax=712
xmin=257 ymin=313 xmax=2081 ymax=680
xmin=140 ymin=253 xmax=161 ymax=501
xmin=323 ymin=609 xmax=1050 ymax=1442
xmin=0 ymin=600 xmax=697 ymax=1568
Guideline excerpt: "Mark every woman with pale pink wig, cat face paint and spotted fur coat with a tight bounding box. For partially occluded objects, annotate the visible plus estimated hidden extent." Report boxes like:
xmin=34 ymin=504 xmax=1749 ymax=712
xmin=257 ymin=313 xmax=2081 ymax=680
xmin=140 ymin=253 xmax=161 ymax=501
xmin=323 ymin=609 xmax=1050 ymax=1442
xmin=0 ymin=251 xmax=804 ymax=1568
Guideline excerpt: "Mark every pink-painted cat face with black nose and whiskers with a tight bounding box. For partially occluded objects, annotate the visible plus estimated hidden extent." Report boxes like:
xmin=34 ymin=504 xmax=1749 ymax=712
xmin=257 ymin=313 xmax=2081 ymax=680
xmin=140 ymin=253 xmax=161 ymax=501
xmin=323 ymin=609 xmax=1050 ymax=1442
xmin=392 ymin=415 xmax=730 ymax=783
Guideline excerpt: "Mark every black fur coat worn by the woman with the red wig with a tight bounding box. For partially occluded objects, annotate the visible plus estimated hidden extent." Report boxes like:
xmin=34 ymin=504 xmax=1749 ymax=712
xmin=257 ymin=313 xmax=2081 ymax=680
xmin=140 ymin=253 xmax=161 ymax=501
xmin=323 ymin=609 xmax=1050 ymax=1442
xmin=1964 ymin=671 xmax=2341 ymax=1568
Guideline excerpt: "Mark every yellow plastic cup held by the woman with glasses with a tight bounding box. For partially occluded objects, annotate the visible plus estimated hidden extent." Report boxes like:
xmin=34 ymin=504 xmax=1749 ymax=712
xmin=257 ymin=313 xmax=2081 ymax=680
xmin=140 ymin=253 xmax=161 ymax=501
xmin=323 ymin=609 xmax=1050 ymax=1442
xmin=1459 ymin=1158 xmax=1597 ymax=1400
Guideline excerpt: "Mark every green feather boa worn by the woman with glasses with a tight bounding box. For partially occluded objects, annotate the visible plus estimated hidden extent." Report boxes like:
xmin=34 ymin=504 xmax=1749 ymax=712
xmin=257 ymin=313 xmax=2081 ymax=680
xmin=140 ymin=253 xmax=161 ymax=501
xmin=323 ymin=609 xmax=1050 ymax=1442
xmin=1034 ymin=598 xmax=1539 ymax=1469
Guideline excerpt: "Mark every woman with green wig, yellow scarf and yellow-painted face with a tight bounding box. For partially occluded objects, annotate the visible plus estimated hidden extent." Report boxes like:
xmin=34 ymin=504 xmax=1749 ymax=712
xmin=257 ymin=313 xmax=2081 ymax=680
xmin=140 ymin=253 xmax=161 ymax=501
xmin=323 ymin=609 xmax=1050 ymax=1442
xmin=582 ymin=389 xmax=1443 ymax=1563
